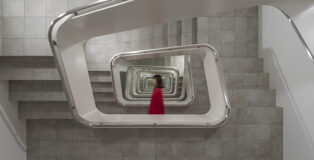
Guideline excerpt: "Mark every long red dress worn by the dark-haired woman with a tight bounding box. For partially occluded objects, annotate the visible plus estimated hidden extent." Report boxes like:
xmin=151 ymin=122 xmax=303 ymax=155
xmin=148 ymin=88 xmax=165 ymax=114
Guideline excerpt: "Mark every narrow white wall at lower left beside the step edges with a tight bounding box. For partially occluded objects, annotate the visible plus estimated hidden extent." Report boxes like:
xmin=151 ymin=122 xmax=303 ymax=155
xmin=0 ymin=81 xmax=26 ymax=160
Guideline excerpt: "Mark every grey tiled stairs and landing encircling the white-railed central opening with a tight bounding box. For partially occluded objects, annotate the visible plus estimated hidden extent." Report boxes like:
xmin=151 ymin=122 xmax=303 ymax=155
xmin=0 ymin=3 xmax=283 ymax=160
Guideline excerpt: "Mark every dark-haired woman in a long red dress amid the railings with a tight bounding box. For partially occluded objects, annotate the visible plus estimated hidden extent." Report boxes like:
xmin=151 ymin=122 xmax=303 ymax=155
xmin=148 ymin=75 xmax=165 ymax=114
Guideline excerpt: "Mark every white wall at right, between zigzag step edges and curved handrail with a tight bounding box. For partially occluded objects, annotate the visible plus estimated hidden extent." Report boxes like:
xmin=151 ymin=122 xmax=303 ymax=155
xmin=259 ymin=6 xmax=314 ymax=160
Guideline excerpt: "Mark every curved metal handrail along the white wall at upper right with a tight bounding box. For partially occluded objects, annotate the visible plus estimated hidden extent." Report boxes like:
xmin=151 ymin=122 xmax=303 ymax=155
xmin=272 ymin=6 xmax=314 ymax=63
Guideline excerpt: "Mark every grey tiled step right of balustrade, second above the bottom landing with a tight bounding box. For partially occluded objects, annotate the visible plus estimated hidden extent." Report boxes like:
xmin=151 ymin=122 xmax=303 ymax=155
xmin=224 ymin=72 xmax=269 ymax=89
